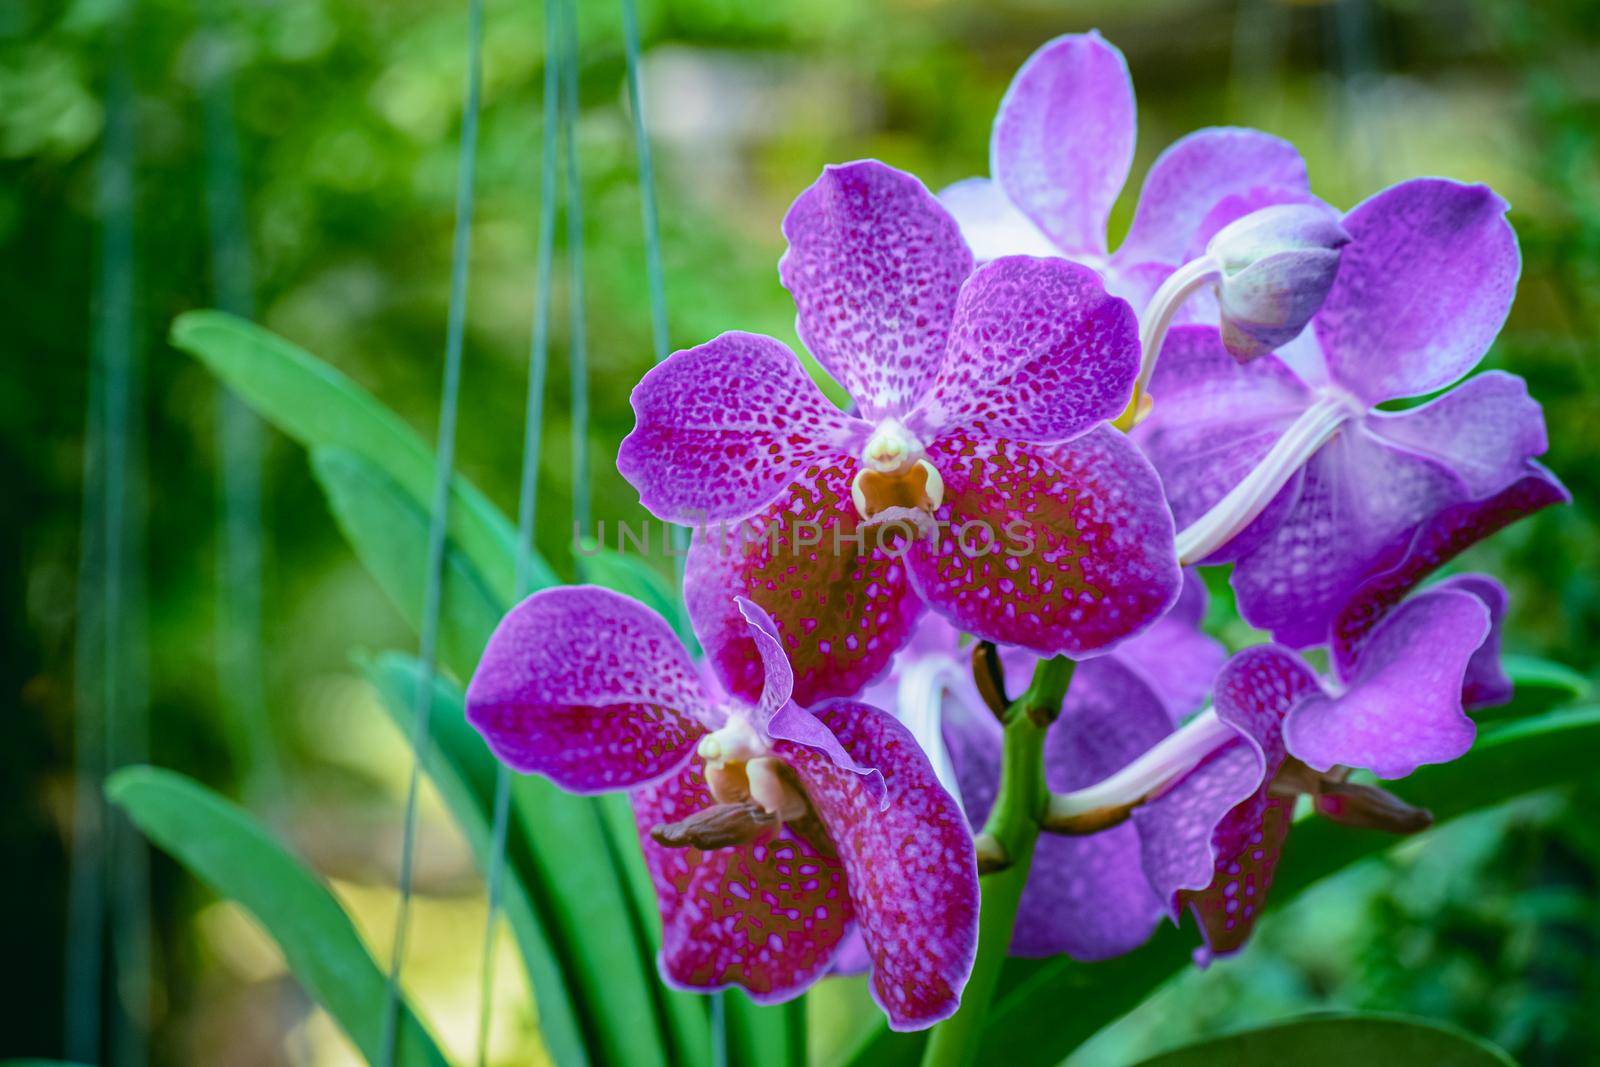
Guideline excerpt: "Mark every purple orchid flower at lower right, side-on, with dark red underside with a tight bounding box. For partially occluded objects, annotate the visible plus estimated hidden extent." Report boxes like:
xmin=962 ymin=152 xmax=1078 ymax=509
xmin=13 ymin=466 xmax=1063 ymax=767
xmin=1133 ymin=584 xmax=1498 ymax=963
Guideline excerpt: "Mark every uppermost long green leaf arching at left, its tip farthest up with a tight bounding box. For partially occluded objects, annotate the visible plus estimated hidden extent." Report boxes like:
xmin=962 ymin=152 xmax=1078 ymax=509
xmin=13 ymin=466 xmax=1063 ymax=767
xmin=171 ymin=310 xmax=557 ymax=603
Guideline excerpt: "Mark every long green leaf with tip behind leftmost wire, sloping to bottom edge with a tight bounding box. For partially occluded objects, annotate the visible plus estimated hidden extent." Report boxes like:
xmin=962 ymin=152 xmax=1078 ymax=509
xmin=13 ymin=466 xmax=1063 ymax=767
xmin=362 ymin=653 xmax=603 ymax=1067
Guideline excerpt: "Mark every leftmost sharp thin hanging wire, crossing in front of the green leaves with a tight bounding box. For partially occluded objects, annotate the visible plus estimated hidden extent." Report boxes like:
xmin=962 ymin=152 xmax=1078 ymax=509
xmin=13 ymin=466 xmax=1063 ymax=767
xmin=378 ymin=0 xmax=483 ymax=1067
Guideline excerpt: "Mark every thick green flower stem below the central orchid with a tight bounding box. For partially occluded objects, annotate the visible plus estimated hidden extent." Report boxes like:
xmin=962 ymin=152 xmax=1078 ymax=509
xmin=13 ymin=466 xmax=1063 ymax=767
xmin=922 ymin=656 xmax=1075 ymax=1067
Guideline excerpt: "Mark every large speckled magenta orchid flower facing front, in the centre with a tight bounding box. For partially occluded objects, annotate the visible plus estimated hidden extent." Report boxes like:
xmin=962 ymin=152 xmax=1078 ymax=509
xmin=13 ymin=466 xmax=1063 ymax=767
xmin=618 ymin=162 xmax=1179 ymax=704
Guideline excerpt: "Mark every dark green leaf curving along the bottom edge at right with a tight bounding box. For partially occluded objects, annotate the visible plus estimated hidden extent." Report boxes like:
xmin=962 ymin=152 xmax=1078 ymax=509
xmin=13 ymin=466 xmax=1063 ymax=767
xmin=1138 ymin=1014 xmax=1517 ymax=1067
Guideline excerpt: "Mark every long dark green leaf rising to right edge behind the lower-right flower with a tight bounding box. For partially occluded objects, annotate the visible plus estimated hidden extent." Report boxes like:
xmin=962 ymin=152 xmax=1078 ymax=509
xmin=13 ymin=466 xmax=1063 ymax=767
xmin=850 ymin=705 xmax=1600 ymax=1067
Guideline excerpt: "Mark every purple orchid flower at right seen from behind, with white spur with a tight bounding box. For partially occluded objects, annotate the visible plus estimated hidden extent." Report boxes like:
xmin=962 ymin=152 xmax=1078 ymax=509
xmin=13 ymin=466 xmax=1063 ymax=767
xmin=1139 ymin=179 xmax=1546 ymax=646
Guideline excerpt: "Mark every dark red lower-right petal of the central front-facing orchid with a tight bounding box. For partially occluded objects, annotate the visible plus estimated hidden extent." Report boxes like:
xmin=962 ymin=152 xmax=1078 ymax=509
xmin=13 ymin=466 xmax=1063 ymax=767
xmin=907 ymin=427 xmax=1182 ymax=656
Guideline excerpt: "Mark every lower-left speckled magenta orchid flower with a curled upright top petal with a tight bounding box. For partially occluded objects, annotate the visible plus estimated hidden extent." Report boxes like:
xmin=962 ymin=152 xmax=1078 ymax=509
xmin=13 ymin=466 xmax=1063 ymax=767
xmin=467 ymin=587 xmax=978 ymax=1029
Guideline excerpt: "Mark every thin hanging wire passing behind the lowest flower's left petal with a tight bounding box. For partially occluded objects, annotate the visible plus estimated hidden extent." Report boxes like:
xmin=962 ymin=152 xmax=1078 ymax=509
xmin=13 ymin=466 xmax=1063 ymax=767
xmin=478 ymin=0 xmax=562 ymax=1067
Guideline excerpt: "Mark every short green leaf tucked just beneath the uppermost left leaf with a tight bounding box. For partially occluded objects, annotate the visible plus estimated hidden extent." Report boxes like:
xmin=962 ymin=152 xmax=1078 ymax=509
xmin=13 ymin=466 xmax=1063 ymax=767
xmin=310 ymin=446 xmax=501 ymax=678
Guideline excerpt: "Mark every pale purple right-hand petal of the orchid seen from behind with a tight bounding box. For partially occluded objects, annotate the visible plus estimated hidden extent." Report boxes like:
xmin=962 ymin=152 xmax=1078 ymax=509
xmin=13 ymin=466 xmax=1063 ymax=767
xmin=1366 ymin=371 xmax=1547 ymax=498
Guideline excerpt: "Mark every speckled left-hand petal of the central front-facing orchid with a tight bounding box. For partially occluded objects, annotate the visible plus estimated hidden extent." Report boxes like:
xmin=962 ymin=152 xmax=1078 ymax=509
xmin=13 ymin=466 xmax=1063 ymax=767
xmin=616 ymin=333 xmax=870 ymax=525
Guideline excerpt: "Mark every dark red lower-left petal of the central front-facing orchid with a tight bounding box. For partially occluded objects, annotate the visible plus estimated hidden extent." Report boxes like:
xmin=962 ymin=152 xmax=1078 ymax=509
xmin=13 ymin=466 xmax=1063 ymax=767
xmin=683 ymin=466 xmax=923 ymax=707
